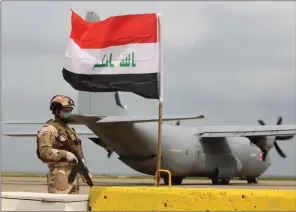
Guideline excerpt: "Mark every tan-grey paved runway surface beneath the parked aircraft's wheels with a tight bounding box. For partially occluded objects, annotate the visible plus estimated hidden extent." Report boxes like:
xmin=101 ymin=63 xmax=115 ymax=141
xmin=1 ymin=177 xmax=296 ymax=194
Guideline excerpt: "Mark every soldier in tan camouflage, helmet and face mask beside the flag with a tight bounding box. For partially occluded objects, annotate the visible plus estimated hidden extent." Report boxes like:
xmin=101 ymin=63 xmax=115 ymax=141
xmin=37 ymin=95 xmax=91 ymax=194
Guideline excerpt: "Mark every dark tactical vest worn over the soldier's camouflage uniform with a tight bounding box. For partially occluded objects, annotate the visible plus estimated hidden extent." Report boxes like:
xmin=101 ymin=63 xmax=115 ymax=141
xmin=36 ymin=119 xmax=84 ymax=163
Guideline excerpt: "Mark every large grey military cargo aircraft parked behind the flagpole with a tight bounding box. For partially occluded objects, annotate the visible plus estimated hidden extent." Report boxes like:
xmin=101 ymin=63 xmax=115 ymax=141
xmin=4 ymin=92 xmax=296 ymax=185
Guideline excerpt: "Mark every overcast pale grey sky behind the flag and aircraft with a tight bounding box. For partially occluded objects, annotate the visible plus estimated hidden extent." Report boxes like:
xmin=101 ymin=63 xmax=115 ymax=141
xmin=1 ymin=1 xmax=296 ymax=175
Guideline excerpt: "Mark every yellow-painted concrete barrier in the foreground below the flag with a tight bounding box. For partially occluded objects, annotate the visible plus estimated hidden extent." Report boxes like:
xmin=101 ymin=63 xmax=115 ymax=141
xmin=89 ymin=186 xmax=296 ymax=211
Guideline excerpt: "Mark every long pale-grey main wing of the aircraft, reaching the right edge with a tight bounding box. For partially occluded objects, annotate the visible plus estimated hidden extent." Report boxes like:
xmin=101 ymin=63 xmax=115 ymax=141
xmin=197 ymin=125 xmax=296 ymax=138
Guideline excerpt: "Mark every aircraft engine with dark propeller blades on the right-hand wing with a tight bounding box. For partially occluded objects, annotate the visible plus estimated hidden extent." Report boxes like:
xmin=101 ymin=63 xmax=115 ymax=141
xmin=249 ymin=117 xmax=294 ymax=161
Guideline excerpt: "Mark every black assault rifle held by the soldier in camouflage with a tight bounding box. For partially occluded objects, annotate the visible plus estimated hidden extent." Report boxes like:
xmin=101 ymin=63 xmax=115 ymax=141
xmin=68 ymin=148 xmax=93 ymax=187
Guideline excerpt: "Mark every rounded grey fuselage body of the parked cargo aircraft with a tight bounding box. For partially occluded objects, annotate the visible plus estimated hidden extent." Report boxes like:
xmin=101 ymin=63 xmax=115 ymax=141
xmin=95 ymin=123 xmax=270 ymax=178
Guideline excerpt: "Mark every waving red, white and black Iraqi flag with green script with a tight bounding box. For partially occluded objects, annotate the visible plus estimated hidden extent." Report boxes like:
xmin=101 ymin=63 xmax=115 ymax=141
xmin=62 ymin=11 xmax=160 ymax=99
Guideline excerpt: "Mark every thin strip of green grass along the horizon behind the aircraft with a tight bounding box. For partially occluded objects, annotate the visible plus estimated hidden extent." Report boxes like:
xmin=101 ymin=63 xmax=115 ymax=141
xmin=1 ymin=172 xmax=296 ymax=181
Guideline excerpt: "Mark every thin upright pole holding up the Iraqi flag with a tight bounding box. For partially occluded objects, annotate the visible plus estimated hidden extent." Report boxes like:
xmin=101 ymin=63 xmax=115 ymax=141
xmin=156 ymin=13 xmax=163 ymax=186
